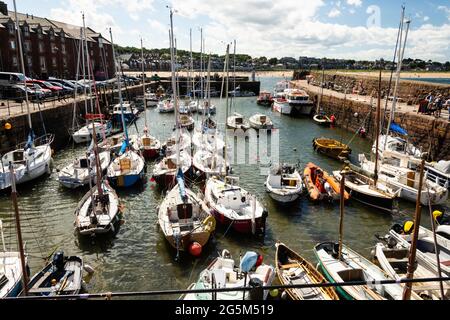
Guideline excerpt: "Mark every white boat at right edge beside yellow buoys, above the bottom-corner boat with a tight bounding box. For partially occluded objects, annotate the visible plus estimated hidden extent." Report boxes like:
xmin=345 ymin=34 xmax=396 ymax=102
xmin=389 ymin=224 xmax=450 ymax=276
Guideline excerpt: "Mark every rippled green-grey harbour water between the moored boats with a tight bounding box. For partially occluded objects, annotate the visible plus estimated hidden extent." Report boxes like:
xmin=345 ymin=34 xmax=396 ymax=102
xmin=0 ymin=78 xmax=442 ymax=299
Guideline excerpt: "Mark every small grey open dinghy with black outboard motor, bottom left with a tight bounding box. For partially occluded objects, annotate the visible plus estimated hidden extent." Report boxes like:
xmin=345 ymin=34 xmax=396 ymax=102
xmin=28 ymin=251 xmax=83 ymax=296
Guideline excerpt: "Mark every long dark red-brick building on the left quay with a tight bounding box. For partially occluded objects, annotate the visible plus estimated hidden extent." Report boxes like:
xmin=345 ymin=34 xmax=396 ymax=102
xmin=0 ymin=1 xmax=115 ymax=80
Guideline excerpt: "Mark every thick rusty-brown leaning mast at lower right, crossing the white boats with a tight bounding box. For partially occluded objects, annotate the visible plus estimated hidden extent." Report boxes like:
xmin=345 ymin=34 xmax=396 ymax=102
xmin=402 ymin=159 xmax=425 ymax=300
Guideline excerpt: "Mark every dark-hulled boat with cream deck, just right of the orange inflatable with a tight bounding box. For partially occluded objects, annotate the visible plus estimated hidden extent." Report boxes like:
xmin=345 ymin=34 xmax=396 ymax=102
xmin=333 ymin=170 xmax=398 ymax=213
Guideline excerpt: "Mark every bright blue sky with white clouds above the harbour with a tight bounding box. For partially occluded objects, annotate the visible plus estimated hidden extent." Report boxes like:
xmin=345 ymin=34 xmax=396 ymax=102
xmin=3 ymin=0 xmax=450 ymax=62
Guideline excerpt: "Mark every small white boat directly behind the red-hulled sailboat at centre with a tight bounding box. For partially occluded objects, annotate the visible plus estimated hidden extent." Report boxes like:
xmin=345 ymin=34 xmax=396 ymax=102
xmin=192 ymin=149 xmax=226 ymax=181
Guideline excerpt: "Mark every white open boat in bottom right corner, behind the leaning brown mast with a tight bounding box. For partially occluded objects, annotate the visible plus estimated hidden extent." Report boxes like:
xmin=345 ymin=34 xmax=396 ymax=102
xmin=374 ymin=238 xmax=450 ymax=300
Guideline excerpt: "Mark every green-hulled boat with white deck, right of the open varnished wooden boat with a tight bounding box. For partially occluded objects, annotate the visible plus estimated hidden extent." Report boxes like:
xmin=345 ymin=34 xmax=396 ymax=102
xmin=314 ymin=242 xmax=412 ymax=300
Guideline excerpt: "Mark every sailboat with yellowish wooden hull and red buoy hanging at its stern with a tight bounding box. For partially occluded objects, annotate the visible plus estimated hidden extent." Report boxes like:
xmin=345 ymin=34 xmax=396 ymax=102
xmin=158 ymin=169 xmax=216 ymax=256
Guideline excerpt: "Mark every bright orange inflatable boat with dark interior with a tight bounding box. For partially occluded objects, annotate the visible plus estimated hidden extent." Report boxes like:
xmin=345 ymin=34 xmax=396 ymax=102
xmin=303 ymin=162 xmax=350 ymax=201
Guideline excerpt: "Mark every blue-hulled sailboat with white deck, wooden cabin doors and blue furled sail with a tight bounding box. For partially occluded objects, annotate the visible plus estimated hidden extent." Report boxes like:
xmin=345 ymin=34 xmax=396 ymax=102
xmin=106 ymin=141 xmax=145 ymax=188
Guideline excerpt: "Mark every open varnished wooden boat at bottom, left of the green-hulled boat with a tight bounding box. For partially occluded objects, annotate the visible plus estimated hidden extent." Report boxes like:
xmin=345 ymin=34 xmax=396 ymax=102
xmin=275 ymin=243 xmax=339 ymax=300
